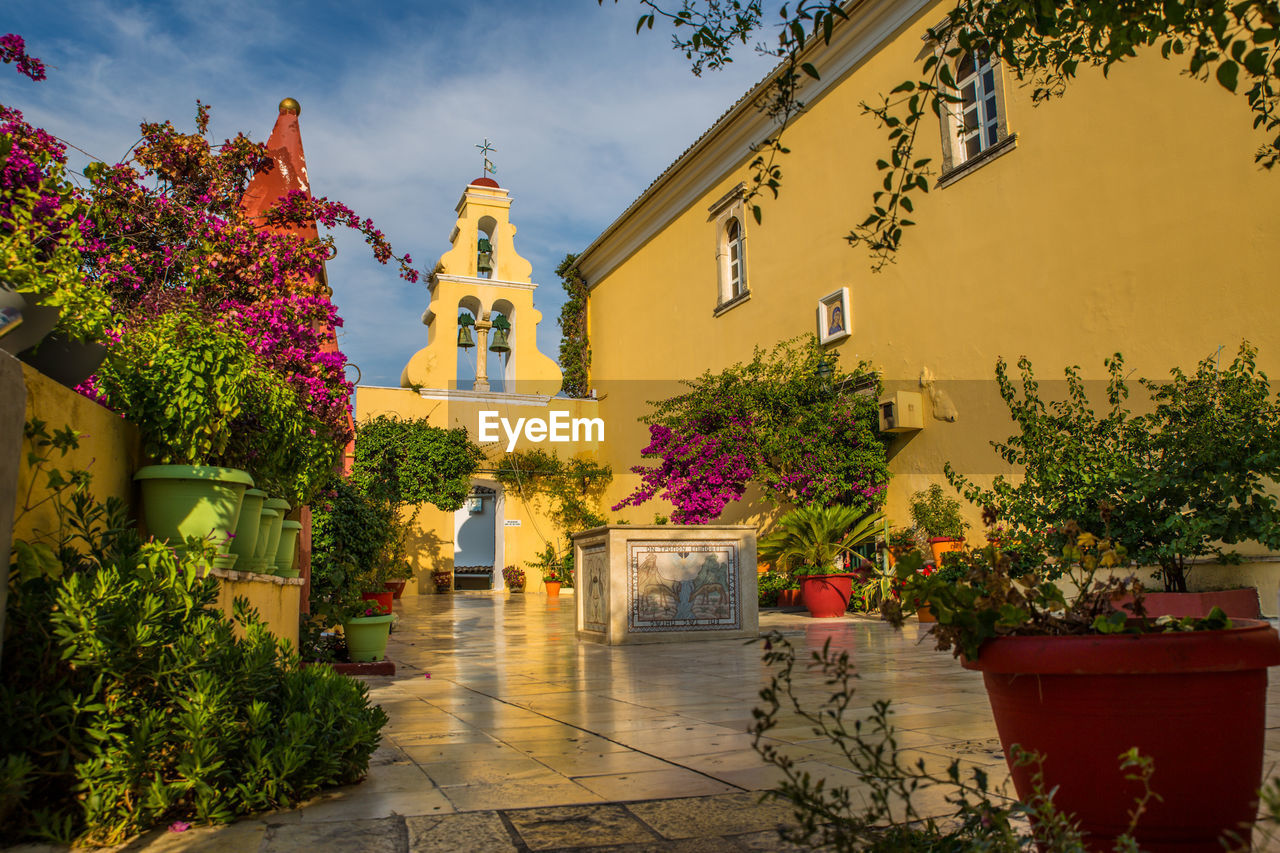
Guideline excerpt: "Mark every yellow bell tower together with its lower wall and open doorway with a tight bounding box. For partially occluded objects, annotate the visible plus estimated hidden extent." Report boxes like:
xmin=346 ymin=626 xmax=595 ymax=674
xmin=356 ymin=178 xmax=604 ymax=593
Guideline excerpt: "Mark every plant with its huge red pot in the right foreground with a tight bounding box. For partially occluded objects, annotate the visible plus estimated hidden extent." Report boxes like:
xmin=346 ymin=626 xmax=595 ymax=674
xmin=883 ymin=525 xmax=1280 ymax=849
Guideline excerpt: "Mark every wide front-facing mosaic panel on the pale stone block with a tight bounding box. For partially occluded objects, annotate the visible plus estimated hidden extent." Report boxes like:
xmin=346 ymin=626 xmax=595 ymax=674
xmin=627 ymin=542 xmax=742 ymax=633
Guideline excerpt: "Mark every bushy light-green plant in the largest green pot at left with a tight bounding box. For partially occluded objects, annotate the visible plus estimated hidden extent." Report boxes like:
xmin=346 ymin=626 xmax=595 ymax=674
xmin=97 ymin=307 xmax=339 ymax=557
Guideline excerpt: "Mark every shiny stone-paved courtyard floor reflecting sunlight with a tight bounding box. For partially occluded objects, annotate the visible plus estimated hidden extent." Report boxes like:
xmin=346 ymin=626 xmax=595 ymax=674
xmin=24 ymin=593 xmax=1280 ymax=853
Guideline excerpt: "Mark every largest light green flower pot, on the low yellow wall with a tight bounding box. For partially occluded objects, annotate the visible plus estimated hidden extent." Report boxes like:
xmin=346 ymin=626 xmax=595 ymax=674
xmin=133 ymin=465 xmax=253 ymax=553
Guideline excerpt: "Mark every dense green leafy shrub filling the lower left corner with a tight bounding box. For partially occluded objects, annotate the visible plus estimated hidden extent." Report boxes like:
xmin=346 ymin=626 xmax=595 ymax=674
xmin=0 ymin=492 xmax=387 ymax=844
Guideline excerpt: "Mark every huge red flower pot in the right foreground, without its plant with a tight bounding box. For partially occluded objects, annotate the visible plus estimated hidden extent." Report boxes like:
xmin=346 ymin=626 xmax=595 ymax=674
xmin=964 ymin=620 xmax=1280 ymax=853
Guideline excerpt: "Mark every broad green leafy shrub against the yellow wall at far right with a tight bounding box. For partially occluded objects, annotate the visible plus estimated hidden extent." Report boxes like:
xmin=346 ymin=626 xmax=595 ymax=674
xmin=946 ymin=343 xmax=1280 ymax=592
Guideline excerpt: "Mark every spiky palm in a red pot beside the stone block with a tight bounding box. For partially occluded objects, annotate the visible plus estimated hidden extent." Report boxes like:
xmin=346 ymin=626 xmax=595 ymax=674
xmin=759 ymin=506 xmax=883 ymax=619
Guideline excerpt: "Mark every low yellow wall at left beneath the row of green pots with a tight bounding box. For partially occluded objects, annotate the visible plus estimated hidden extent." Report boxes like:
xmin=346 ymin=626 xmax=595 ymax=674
xmin=13 ymin=365 xmax=302 ymax=637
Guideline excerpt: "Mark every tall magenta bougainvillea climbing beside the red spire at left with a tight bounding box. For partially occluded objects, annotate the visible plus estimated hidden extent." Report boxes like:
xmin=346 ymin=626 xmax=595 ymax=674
xmin=0 ymin=35 xmax=419 ymax=479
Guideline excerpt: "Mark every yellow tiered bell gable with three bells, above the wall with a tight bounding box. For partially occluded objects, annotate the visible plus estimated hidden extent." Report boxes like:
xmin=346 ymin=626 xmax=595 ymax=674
xmin=401 ymin=177 xmax=562 ymax=397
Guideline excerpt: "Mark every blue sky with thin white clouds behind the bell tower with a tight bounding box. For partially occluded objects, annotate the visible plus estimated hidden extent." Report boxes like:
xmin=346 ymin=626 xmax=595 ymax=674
xmin=0 ymin=0 xmax=769 ymax=386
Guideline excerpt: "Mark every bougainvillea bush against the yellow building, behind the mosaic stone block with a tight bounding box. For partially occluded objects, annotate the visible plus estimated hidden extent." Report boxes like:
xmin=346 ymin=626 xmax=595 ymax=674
xmin=613 ymin=336 xmax=888 ymax=524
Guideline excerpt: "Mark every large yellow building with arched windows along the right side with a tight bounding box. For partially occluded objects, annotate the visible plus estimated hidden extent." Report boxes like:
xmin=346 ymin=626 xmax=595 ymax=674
xmin=577 ymin=0 xmax=1280 ymax=596
